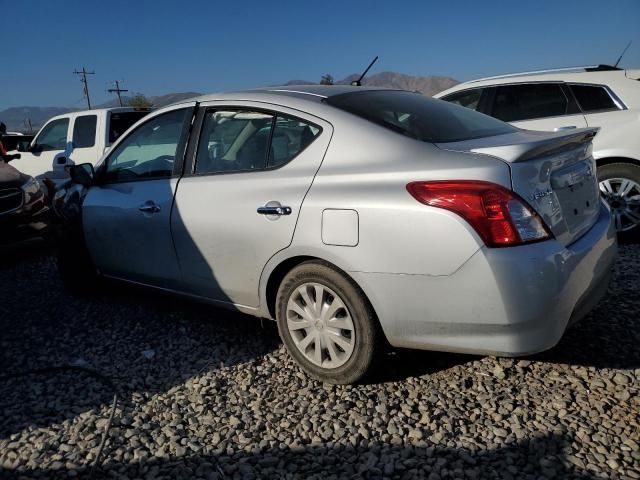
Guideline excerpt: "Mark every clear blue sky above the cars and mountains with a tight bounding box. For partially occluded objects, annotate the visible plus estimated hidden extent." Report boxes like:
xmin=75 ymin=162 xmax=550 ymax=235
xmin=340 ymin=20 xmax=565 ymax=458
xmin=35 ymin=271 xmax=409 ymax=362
xmin=0 ymin=0 xmax=640 ymax=109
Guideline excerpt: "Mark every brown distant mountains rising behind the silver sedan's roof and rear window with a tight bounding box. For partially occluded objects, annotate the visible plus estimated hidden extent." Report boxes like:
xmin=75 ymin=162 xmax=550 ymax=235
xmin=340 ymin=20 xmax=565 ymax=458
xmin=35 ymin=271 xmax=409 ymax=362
xmin=285 ymin=72 xmax=460 ymax=95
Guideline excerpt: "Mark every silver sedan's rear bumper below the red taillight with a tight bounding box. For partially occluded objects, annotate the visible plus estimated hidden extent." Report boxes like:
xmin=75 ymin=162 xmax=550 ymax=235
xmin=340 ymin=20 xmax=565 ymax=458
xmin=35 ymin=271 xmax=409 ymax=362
xmin=350 ymin=205 xmax=617 ymax=356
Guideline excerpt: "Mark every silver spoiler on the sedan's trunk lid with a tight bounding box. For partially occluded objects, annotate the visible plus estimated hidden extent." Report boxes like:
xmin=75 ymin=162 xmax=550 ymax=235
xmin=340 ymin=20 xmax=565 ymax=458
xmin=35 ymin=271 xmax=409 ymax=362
xmin=471 ymin=128 xmax=600 ymax=163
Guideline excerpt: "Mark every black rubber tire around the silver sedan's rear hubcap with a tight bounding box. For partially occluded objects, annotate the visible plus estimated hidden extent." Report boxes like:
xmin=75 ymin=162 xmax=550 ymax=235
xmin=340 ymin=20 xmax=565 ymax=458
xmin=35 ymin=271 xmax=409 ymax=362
xmin=276 ymin=261 xmax=382 ymax=384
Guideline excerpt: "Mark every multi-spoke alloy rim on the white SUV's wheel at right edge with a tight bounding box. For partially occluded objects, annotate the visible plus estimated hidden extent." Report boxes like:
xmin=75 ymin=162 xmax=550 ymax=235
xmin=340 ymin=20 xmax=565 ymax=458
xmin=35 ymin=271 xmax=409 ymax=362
xmin=600 ymin=178 xmax=640 ymax=232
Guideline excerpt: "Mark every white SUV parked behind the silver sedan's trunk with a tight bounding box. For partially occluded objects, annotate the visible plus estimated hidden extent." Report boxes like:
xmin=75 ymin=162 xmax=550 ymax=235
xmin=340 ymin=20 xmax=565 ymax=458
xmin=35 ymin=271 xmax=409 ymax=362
xmin=434 ymin=65 xmax=640 ymax=232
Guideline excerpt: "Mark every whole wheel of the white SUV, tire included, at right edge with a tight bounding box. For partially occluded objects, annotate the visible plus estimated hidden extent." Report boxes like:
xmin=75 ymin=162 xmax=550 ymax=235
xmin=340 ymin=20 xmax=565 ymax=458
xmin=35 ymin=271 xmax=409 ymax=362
xmin=598 ymin=163 xmax=640 ymax=232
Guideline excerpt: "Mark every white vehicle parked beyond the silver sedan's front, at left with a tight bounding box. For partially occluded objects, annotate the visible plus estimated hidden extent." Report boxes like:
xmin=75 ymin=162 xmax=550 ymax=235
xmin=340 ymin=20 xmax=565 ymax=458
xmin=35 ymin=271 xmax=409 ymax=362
xmin=11 ymin=107 xmax=151 ymax=179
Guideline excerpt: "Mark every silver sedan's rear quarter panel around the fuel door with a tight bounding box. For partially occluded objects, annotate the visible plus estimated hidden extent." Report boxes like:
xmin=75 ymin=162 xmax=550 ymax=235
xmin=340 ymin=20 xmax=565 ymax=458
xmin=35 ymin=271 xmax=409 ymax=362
xmin=262 ymin=115 xmax=510 ymax=316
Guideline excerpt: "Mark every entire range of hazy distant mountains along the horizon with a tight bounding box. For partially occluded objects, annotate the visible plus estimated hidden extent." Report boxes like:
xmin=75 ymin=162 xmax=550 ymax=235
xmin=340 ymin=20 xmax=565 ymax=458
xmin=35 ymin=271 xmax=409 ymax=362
xmin=0 ymin=72 xmax=459 ymax=131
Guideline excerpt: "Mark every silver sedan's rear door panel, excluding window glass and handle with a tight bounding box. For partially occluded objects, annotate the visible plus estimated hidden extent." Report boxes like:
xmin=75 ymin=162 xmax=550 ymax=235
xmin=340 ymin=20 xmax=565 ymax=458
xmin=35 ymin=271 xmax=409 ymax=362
xmin=171 ymin=101 xmax=333 ymax=308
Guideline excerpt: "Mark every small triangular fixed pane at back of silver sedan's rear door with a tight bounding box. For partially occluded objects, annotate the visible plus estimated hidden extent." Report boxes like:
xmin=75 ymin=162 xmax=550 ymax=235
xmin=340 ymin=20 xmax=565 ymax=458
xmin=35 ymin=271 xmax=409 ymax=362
xmin=267 ymin=114 xmax=320 ymax=167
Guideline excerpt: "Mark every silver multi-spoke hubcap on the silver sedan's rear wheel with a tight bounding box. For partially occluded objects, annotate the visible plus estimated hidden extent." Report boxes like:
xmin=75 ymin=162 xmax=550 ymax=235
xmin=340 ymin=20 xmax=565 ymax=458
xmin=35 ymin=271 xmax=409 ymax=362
xmin=286 ymin=283 xmax=356 ymax=368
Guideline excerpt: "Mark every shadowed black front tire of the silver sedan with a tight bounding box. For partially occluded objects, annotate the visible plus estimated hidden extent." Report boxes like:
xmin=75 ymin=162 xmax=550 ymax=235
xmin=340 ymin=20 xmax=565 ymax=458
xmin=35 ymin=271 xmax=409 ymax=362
xmin=56 ymin=225 xmax=98 ymax=294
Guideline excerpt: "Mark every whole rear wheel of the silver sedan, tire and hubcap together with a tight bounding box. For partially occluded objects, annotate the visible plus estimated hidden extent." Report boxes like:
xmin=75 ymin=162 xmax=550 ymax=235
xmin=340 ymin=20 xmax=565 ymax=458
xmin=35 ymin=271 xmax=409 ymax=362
xmin=276 ymin=261 xmax=381 ymax=384
